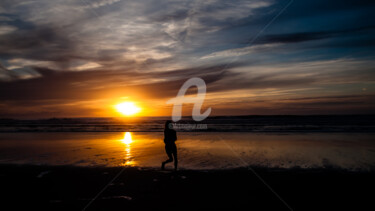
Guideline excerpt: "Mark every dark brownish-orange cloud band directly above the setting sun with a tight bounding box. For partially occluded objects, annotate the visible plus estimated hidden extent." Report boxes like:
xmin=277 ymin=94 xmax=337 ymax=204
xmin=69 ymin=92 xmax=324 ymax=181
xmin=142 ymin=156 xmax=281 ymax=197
xmin=0 ymin=64 xmax=244 ymax=100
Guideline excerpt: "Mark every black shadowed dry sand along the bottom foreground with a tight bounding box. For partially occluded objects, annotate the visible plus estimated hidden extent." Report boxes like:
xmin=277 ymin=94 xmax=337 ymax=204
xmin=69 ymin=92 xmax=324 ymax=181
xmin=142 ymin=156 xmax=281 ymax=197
xmin=0 ymin=165 xmax=375 ymax=210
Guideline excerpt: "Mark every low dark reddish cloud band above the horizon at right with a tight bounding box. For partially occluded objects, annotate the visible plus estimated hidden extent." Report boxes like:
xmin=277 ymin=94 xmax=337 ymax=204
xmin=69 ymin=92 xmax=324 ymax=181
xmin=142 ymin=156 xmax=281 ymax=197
xmin=214 ymin=95 xmax=375 ymax=115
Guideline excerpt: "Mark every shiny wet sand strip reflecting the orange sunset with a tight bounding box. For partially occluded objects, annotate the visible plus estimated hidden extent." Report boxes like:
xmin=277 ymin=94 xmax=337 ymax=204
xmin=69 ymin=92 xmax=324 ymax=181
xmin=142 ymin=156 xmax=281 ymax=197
xmin=0 ymin=132 xmax=375 ymax=171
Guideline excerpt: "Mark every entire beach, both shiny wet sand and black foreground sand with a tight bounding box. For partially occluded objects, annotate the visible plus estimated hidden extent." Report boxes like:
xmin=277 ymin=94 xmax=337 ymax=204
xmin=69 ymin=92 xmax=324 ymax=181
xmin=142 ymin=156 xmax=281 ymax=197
xmin=0 ymin=132 xmax=375 ymax=211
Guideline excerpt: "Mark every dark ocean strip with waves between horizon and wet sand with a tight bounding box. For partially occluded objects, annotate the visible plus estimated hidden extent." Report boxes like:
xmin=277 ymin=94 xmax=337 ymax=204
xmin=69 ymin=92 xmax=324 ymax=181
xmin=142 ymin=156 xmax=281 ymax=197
xmin=0 ymin=115 xmax=375 ymax=133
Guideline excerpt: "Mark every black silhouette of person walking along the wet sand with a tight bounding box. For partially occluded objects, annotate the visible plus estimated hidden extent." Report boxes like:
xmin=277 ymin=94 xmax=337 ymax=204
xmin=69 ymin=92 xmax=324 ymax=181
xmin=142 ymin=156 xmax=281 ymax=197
xmin=161 ymin=120 xmax=178 ymax=171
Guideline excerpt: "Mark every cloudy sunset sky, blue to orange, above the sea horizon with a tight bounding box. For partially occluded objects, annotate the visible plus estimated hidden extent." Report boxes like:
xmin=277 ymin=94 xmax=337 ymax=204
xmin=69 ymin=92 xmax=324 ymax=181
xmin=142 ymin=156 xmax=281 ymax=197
xmin=0 ymin=0 xmax=375 ymax=118
